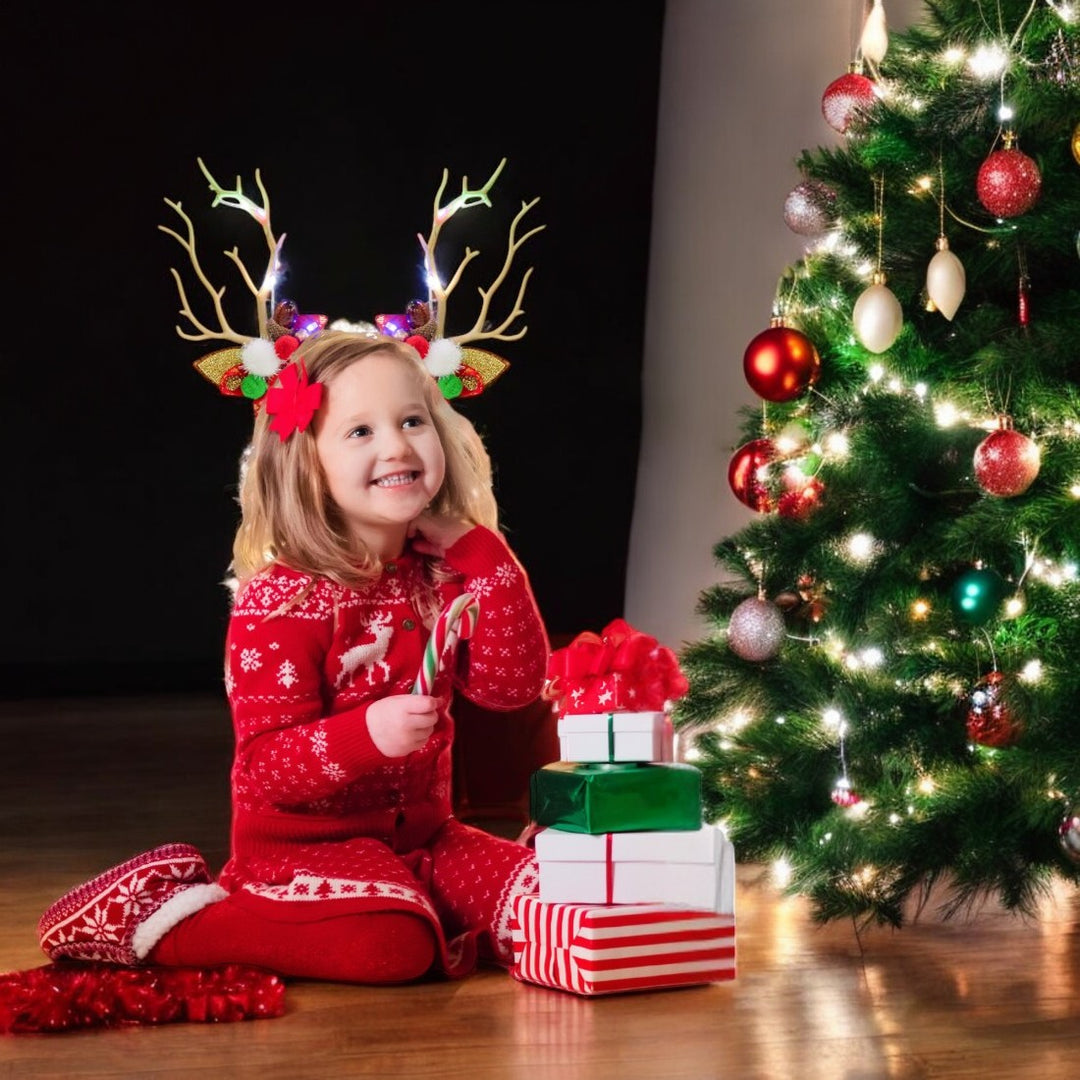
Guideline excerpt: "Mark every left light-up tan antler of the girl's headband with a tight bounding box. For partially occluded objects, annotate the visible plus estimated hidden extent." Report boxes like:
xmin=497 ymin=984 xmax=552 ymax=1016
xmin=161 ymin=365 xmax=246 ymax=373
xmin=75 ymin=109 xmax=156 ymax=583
xmin=158 ymin=158 xmax=285 ymax=345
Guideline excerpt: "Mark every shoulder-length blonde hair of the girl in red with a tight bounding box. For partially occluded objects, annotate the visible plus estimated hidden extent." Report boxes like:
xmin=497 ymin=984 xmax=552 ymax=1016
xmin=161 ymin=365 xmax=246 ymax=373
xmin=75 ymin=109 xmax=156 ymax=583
xmin=230 ymin=330 xmax=498 ymax=586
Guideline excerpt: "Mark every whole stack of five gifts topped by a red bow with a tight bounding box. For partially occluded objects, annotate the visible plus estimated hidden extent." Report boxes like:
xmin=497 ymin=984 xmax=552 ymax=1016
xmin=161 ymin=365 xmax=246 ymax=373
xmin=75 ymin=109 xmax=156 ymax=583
xmin=512 ymin=620 xmax=735 ymax=995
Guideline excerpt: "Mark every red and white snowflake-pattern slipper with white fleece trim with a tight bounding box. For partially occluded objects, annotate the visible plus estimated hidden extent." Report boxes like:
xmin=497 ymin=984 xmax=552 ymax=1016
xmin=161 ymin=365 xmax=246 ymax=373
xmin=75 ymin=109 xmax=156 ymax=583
xmin=38 ymin=843 xmax=227 ymax=964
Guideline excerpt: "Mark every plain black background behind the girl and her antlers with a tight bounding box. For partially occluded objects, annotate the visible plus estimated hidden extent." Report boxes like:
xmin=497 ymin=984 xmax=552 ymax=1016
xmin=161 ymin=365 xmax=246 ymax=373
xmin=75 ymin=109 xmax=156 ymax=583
xmin=0 ymin=0 xmax=663 ymax=698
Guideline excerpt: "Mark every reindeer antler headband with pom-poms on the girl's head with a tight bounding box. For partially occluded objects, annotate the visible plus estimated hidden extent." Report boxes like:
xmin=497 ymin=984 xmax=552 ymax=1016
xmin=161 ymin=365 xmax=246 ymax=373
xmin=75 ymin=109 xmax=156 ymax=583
xmin=158 ymin=158 xmax=544 ymax=429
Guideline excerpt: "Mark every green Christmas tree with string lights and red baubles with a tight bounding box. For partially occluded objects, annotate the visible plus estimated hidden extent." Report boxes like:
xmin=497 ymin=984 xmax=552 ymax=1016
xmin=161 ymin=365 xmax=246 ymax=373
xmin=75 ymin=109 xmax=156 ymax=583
xmin=675 ymin=0 xmax=1080 ymax=927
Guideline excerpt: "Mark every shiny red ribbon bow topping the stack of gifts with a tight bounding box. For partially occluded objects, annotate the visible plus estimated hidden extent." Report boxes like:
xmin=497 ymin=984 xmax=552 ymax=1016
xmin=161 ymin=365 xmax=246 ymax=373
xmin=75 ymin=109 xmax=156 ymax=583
xmin=544 ymin=619 xmax=689 ymax=713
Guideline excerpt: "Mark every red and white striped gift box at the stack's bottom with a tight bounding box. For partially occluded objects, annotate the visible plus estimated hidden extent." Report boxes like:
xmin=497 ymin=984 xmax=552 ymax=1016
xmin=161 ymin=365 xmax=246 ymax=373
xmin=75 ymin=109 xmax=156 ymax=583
xmin=511 ymin=895 xmax=735 ymax=995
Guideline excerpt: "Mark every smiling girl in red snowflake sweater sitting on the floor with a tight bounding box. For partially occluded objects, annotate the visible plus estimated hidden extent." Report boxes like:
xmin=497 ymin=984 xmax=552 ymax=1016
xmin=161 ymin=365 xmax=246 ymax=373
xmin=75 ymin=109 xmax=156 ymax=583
xmin=39 ymin=330 xmax=549 ymax=983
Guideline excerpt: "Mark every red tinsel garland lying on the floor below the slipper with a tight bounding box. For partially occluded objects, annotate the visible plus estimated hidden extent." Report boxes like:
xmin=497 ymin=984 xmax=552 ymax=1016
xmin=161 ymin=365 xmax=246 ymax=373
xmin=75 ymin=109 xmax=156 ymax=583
xmin=0 ymin=961 xmax=285 ymax=1035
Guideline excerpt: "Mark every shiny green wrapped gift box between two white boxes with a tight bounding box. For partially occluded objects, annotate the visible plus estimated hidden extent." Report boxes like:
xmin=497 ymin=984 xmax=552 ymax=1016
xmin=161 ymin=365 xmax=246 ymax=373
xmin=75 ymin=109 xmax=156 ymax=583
xmin=529 ymin=761 xmax=701 ymax=834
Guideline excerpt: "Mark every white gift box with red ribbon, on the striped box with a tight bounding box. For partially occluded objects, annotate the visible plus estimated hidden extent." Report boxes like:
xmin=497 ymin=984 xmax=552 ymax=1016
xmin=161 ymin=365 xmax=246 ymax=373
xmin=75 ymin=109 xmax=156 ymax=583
xmin=532 ymin=825 xmax=735 ymax=915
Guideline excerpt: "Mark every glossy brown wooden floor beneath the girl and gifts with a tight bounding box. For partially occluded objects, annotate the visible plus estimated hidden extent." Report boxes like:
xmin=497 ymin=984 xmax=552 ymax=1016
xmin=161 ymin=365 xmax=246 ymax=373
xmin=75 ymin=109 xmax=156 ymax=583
xmin=0 ymin=697 xmax=1080 ymax=1080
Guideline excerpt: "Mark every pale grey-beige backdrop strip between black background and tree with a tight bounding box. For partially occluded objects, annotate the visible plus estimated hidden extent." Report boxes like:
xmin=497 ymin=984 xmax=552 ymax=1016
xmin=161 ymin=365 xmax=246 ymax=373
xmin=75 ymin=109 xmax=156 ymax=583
xmin=625 ymin=0 xmax=922 ymax=649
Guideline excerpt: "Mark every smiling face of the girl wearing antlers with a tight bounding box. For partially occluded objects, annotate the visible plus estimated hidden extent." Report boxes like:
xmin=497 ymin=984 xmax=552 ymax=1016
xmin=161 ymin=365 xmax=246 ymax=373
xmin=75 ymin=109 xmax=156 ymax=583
xmin=314 ymin=352 xmax=446 ymax=558
